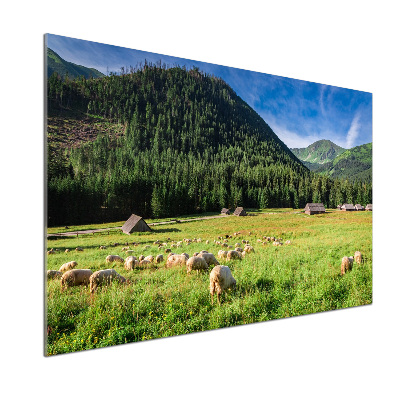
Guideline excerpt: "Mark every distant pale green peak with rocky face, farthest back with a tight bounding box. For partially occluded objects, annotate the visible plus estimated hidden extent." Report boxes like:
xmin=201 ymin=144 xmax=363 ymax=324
xmin=290 ymin=140 xmax=345 ymax=165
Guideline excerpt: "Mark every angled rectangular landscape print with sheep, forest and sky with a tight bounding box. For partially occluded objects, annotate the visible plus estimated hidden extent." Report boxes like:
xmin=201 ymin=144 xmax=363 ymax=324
xmin=45 ymin=34 xmax=372 ymax=355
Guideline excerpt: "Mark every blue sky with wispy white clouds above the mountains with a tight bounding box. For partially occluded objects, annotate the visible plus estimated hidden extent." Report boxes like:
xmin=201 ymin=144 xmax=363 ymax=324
xmin=47 ymin=34 xmax=372 ymax=149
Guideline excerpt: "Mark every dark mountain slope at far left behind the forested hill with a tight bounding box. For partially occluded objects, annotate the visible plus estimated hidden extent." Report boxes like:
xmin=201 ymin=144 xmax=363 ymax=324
xmin=47 ymin=48 xmax=104 ymax=79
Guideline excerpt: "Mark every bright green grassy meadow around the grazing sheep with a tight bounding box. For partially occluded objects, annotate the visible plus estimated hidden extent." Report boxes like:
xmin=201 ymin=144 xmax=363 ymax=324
xmin=47 ymin=210 xmax=372 ymax=355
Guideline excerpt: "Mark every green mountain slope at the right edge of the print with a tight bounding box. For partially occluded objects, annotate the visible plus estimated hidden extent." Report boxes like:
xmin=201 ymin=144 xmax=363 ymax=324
xmin=315 ymin=143 xmax=372 ymax=182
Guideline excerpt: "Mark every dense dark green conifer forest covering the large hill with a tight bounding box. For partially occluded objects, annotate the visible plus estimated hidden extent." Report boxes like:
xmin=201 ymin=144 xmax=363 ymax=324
xmin=48 ymin=64 xmax=372 ymax=225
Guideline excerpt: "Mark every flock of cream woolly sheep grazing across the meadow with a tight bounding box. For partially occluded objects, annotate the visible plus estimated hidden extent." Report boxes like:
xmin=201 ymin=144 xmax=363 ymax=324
xmin=47 ymin=232 xmax=362 ymax=304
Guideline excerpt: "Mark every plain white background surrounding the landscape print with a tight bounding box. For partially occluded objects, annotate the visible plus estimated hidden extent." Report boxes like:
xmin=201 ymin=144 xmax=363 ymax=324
xmin=0 ymin=0 xmax=400 ymax=399
